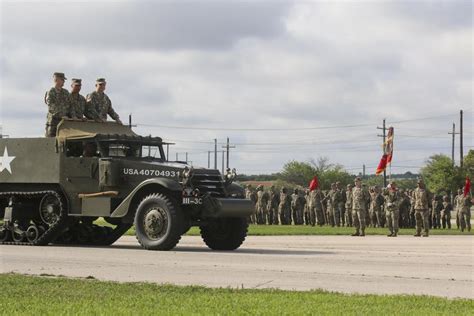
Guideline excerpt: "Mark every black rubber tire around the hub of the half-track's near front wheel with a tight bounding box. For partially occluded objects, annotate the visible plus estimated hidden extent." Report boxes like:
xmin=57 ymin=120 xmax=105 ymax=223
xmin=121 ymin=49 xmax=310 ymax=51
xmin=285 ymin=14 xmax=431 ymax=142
xmin=134 ymin=193 xmax=183 ymax=250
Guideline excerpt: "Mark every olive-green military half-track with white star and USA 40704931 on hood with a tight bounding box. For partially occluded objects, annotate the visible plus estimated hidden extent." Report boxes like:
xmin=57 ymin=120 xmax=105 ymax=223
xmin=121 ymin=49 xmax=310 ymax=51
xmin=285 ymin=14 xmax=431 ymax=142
xmin=0 ymin=120 xmax=254 ymax=250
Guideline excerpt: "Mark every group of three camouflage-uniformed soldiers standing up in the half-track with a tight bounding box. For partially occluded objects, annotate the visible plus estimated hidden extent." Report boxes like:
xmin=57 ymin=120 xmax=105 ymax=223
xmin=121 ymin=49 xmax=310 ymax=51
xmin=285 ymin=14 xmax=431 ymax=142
xmin=44 ymin=72 xmax=122 ymax=137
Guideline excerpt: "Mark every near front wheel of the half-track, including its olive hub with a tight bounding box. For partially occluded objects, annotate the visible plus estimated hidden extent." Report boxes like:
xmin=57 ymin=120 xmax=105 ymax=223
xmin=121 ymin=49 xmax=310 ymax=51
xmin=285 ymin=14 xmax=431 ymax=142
xmin=134 ymin=193 xmax=183 ymax=250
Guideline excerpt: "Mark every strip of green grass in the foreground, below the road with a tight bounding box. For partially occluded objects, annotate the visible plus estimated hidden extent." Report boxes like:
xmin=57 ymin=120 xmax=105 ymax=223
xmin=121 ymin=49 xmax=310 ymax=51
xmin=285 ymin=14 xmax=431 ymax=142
xmin=0 ymin=274 xmax=474 ymax=315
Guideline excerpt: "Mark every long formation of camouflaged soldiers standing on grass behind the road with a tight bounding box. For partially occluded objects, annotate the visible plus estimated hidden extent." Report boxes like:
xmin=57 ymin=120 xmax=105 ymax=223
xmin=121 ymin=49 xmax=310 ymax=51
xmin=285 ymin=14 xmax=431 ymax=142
xmin=245 ymin=178 xmax=471 ymax=237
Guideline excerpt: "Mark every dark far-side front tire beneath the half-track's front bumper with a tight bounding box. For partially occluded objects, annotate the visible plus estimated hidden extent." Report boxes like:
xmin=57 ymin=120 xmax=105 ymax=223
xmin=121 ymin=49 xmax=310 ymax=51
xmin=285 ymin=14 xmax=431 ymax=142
xmin=201 ymin=218 xmax=249 ymax=250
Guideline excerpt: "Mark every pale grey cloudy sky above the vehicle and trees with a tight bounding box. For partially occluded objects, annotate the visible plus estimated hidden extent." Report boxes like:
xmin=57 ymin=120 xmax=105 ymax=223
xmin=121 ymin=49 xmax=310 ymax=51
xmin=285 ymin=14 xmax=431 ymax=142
xmin=0 ymin=0 xmax=473 ymax=174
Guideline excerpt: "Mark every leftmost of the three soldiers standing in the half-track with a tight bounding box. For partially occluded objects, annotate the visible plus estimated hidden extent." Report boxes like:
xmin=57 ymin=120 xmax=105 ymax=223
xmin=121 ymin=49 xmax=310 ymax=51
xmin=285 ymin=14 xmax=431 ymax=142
xmin=44 ymin=72 xmax=70 ymax=137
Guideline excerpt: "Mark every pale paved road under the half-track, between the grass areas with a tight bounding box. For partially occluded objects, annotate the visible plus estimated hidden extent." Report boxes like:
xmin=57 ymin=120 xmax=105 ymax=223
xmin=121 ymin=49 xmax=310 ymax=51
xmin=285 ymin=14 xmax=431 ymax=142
xmin=0 ymin=236 xmax=474 ymax=298
